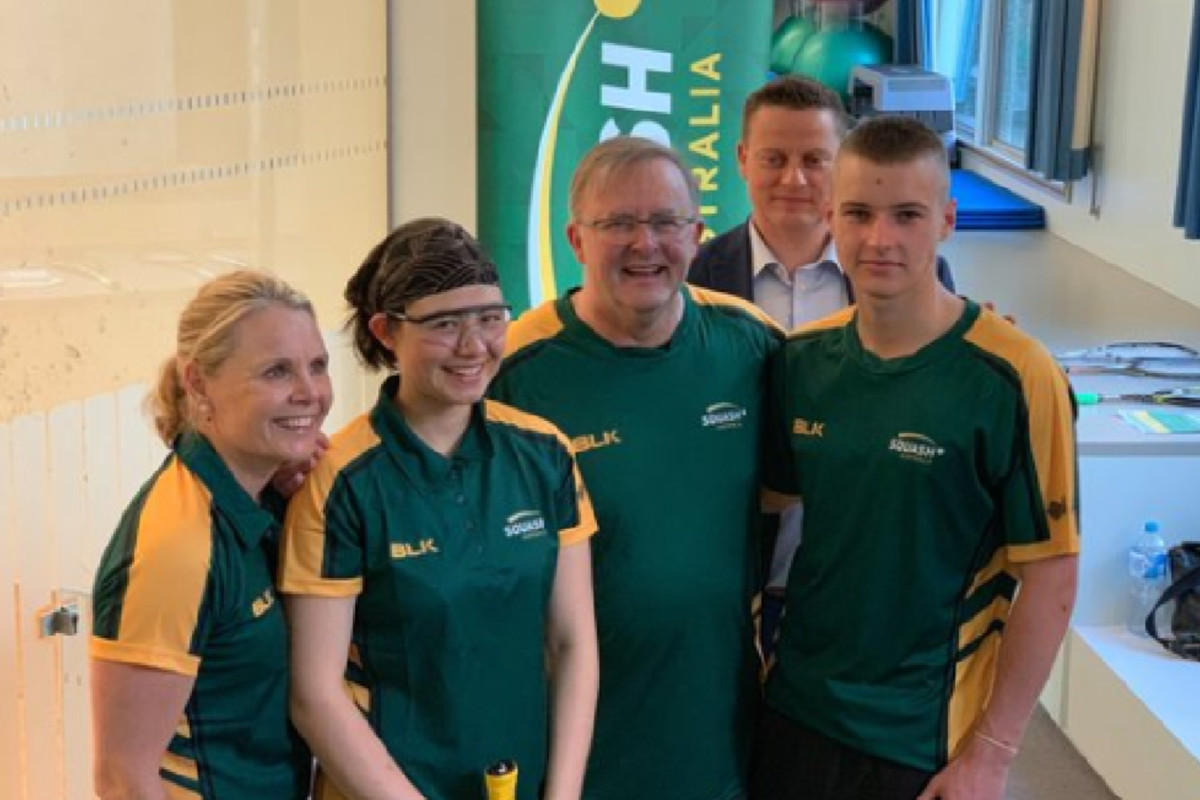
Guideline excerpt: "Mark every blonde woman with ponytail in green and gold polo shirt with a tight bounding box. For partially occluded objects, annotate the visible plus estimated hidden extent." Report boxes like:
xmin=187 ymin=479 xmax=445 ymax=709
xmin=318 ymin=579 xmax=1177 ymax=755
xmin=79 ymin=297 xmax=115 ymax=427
xmin=91 ymin=271 xmax=331 ymax=800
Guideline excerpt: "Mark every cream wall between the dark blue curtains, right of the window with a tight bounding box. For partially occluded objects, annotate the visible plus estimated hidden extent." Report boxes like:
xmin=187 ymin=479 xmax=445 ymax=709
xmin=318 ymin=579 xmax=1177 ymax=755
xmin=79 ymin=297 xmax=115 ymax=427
xmin=964 ymin=0 xmax=1200 ymax=306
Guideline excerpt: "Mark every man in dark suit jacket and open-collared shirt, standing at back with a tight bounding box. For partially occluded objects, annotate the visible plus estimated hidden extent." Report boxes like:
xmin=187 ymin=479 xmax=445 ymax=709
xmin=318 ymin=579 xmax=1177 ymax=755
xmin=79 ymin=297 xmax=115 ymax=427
xmin=688 ymin=76 xmax=954 ymax=654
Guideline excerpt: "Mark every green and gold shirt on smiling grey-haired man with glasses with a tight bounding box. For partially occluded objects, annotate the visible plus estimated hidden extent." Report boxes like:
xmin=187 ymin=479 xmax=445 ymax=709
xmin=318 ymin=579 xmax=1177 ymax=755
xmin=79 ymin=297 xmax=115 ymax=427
xmin=492 ymin=287 xmax=782 ymax=800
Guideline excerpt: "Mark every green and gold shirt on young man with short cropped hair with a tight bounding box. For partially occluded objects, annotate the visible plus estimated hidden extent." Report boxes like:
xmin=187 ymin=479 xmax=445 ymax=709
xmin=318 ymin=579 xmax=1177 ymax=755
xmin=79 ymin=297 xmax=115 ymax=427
xmin=767 ymin=301 xmax=1079 ymax=771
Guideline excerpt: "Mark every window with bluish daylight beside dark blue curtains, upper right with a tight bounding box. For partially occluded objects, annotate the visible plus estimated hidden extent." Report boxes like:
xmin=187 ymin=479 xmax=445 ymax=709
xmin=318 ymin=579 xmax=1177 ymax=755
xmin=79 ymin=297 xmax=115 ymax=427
xmin=931 ymin=0 xmax=1034 ymax=169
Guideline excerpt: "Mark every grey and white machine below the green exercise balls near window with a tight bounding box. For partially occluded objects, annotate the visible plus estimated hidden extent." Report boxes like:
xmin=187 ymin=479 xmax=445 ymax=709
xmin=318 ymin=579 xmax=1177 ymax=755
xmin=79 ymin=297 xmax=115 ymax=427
xmin=850 ymin=64 xmax=955 ymax=162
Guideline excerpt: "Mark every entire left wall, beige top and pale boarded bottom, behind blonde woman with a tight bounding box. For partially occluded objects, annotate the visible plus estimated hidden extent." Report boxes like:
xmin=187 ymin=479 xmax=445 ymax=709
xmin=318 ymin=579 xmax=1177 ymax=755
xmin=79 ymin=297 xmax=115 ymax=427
xmin=0 ymin=0 xmax=388 ymax=800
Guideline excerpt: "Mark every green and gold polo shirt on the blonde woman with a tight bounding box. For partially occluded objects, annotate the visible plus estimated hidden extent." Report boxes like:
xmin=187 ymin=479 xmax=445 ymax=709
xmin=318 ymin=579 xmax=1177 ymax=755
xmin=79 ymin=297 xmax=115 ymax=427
xmin=91 ymin=433 xmax=312 ymax=800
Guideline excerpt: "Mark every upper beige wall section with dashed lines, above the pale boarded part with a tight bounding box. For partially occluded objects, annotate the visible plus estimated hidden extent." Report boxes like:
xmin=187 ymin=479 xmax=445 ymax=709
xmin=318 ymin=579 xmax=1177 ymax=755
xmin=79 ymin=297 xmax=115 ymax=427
xmin=0 ymin=0 xmax=388 ymax=421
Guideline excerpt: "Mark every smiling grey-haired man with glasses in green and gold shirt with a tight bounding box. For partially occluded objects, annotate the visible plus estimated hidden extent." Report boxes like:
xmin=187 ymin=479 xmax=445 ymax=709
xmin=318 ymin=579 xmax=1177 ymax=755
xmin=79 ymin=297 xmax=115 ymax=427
xmin=493 ymin=137 xmax=781 ymax=800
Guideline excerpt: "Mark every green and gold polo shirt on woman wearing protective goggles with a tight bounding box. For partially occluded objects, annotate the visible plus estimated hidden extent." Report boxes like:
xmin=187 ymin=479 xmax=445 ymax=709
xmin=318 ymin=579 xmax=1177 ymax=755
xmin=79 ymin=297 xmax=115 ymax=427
xmin=280 ymin=378 xmax=595 ymax=800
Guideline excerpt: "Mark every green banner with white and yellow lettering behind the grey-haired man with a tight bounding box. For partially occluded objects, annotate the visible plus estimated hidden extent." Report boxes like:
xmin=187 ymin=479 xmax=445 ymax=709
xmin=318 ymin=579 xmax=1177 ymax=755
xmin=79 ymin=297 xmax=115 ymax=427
xmin=476 ymin=0 xmax=773 ymax=309
